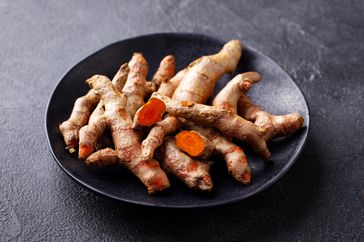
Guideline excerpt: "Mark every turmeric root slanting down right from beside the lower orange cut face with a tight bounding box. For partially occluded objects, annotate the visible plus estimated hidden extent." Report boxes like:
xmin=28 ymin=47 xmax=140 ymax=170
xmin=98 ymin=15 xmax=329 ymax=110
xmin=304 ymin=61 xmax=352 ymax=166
xmin=183 ymin=121 xmax=251 ymax=185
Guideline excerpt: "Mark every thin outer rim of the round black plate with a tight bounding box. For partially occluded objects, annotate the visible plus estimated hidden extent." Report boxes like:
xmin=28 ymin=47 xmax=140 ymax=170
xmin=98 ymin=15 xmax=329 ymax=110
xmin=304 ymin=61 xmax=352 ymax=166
xmin=44 ymin=32 xmax=310 ymax=209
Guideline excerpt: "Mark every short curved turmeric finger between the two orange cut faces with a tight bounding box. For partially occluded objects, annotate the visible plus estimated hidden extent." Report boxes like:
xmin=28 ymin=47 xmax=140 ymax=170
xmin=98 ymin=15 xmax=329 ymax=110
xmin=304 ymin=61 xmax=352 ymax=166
xmin=142 ymin=117 xmax=181 ymax=160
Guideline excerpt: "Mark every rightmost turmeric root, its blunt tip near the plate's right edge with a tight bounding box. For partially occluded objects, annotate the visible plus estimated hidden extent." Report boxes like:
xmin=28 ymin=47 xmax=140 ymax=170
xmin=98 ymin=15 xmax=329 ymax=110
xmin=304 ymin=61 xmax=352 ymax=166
xmin=238 ymin=95 xmax=304 ymax=141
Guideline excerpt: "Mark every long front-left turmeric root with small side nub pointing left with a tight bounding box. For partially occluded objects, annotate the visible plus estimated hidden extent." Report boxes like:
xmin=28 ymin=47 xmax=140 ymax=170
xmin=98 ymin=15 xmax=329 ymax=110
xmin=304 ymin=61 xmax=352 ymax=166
xmin=86 ymin=75 xmax=170 ymax=193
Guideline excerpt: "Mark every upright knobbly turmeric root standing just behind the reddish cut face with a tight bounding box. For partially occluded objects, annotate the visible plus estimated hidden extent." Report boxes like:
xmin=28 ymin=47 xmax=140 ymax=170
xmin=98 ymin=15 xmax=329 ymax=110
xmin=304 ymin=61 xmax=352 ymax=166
xmin=122 ymin=53 xmax=156 ymax=117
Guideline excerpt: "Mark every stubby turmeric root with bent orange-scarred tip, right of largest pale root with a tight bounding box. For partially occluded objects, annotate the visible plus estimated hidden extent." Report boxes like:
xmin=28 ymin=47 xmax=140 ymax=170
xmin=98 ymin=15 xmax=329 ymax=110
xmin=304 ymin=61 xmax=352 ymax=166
xmin=212 ymin=72 xmax=261 ymax=113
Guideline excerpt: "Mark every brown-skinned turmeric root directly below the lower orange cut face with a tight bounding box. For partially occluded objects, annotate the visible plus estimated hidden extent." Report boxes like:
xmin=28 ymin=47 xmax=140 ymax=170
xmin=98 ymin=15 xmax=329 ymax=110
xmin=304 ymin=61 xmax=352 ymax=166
xmin=157 ymin=137 xmax=213 ymax=191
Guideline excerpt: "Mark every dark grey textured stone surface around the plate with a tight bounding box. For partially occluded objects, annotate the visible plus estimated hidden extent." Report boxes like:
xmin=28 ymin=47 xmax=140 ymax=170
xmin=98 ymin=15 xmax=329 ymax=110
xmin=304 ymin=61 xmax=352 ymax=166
xmin=0 ymin=0 xmax=364 ymax=241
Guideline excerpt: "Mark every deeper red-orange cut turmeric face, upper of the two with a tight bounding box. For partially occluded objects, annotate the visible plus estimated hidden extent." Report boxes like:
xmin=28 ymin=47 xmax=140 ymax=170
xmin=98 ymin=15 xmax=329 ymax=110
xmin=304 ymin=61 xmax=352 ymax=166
xmin=136 ymin=98 xmax=166 ymax=126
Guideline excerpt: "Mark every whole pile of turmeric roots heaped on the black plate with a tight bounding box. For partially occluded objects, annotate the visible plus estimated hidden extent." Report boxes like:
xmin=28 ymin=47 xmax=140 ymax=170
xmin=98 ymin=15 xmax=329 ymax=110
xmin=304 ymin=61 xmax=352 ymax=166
xmin=59 ymin=40 xmax=304 ymax=194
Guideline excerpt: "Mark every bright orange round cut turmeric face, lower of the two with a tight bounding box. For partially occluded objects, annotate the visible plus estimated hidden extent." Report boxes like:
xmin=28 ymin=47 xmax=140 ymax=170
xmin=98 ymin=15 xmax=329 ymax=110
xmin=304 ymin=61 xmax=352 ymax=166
xmin=175 ymin=130 xmax=206 ymax=157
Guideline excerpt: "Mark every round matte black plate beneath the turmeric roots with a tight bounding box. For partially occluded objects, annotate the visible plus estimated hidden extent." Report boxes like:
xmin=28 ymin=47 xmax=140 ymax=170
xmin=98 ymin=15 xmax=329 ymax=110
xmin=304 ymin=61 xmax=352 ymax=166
xmin=46 ymin=34 xmax=309 ymax=207
